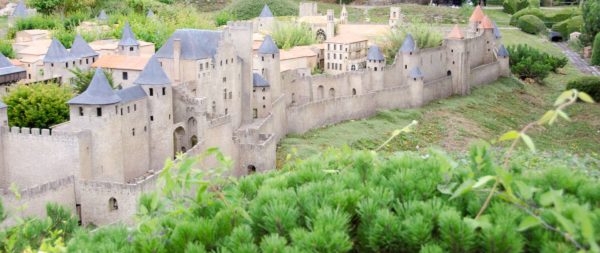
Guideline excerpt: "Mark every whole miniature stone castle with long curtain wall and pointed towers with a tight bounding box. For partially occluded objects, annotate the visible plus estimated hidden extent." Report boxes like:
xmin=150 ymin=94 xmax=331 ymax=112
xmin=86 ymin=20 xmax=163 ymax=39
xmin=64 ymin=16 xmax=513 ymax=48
xmin=0 ymin=5 xmax=510 ymax=225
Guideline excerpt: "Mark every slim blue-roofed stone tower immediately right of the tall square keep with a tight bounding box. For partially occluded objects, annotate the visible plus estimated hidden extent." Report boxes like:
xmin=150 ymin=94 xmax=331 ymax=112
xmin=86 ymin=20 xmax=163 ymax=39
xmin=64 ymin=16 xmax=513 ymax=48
xmin=258 ymin=35 xmax=281 ymax=101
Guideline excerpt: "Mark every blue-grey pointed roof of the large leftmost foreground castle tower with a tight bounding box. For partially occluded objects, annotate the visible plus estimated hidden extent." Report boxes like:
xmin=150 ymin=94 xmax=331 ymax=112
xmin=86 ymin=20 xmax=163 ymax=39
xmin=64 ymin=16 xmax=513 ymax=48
xmin=68 ymin=68 xmax=121 ymax=105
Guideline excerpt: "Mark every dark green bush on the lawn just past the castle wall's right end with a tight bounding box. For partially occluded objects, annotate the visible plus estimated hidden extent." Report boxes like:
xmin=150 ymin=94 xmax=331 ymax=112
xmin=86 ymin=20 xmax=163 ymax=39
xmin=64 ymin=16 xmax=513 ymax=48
xmin=507 ymin=44 xmax=568 ymax=83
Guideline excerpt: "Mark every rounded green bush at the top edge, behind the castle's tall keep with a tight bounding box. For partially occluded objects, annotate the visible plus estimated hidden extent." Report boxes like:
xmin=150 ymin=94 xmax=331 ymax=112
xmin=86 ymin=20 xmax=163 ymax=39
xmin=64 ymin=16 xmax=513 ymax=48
xmin=225 ymin=0 xmax=298 ymax=20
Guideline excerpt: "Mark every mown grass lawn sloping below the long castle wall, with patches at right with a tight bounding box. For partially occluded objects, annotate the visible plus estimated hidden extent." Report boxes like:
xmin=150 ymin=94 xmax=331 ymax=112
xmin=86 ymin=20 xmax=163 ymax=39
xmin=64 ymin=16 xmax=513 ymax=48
xmin=278 ymin=27 xmax=600 ymax=168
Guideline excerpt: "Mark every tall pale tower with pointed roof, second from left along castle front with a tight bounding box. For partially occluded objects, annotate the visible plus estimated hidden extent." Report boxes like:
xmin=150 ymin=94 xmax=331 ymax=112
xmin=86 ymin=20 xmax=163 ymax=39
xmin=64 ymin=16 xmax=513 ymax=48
xmin=133 ymin=56 xmax=173 ymax=171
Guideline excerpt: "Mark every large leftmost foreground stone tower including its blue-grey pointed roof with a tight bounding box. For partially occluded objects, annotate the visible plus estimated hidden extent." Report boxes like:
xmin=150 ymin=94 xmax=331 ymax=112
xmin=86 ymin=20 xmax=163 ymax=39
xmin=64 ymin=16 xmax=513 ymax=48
xmin=68 ymin=68 xmax=125 ymax=183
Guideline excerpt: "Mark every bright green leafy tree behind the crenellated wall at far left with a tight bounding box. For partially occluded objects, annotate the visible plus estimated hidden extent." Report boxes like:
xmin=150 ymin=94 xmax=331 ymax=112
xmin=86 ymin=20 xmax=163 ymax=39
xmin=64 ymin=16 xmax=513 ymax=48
xmin=3 ymin=83 xmax=73 ymax=128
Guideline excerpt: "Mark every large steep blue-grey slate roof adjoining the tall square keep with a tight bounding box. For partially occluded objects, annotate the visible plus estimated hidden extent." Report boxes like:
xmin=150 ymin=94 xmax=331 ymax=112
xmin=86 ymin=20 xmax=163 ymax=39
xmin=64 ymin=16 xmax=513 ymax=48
xmin=156 ymin=29 xmax=222 ymax=60
